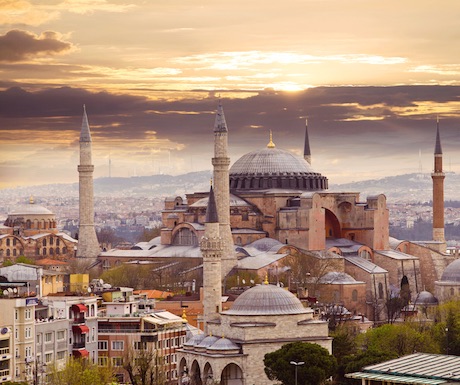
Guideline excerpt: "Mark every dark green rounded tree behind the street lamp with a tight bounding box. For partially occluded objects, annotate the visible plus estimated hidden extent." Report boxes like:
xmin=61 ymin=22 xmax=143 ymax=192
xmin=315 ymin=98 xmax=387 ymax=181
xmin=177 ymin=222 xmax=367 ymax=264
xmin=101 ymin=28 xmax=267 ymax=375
xmin=264 ymin=342 xmax=337 ymax=385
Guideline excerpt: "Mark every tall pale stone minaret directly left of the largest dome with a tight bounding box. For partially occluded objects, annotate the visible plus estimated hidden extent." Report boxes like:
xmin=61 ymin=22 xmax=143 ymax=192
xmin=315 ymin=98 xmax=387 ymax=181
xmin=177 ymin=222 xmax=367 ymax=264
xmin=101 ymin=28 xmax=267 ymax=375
xmin=212 ymin=101 xmax=236 ymax=278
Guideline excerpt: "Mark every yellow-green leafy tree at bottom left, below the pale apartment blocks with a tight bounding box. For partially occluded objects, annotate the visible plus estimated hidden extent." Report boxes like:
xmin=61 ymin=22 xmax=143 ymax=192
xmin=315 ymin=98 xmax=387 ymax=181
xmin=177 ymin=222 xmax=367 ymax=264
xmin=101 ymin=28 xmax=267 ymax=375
xmin=46 ymin=358 xmax=117 ymax=385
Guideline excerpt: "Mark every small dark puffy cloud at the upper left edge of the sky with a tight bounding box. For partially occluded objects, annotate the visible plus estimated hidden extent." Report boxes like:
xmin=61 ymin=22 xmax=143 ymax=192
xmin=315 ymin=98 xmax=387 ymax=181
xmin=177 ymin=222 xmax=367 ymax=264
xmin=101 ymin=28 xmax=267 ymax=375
xmin=0 ymin=29 xmax=73 ymax=62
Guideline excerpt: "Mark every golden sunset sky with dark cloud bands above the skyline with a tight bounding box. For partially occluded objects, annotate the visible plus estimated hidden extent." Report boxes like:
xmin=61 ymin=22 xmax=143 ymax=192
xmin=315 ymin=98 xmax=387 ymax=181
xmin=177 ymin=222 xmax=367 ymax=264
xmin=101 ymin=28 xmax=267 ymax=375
xmin=0 ymin=0 xmax=460 ymax=189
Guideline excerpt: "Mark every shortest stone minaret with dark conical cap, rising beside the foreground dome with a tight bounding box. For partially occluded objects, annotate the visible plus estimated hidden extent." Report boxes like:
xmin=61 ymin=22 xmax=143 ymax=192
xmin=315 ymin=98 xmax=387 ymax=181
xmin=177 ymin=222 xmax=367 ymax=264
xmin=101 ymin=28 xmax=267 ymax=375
xmin=200 ymin=186 xmax=224 ymax=333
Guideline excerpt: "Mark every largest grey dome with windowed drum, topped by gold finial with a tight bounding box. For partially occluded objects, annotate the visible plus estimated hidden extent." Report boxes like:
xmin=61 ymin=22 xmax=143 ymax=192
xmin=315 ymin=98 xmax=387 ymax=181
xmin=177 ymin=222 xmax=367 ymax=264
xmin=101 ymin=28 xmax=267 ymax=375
xmin=229 ymin=147 xmax=328 ymax=190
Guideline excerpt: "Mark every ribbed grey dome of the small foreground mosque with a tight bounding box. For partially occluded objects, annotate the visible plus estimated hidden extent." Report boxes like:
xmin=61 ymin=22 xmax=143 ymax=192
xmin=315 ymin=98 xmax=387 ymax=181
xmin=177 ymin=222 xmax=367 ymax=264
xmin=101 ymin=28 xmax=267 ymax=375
xmin=222 ymin=285 xmax=308 ymax=315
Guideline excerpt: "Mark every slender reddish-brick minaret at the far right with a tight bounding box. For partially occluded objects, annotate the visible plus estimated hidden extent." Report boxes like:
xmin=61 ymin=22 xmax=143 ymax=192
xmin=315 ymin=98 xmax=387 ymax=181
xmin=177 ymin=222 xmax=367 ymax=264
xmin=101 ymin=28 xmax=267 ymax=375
xmin=431 ymin=118 xmax=446 ymax=252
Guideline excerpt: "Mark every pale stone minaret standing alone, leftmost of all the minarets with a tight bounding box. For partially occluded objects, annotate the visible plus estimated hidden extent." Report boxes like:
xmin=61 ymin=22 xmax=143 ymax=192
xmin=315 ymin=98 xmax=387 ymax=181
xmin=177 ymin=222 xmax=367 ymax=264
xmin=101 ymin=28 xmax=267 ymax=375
xmin=77 ymin=106 xmax=100 ymax=259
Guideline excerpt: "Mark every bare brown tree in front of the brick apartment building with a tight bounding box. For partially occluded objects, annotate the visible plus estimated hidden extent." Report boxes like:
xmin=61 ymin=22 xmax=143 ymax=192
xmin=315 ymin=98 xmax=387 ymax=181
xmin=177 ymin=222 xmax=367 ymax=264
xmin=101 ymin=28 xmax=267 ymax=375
xmin=123 ymin=343 xmax=166 ymax=385
